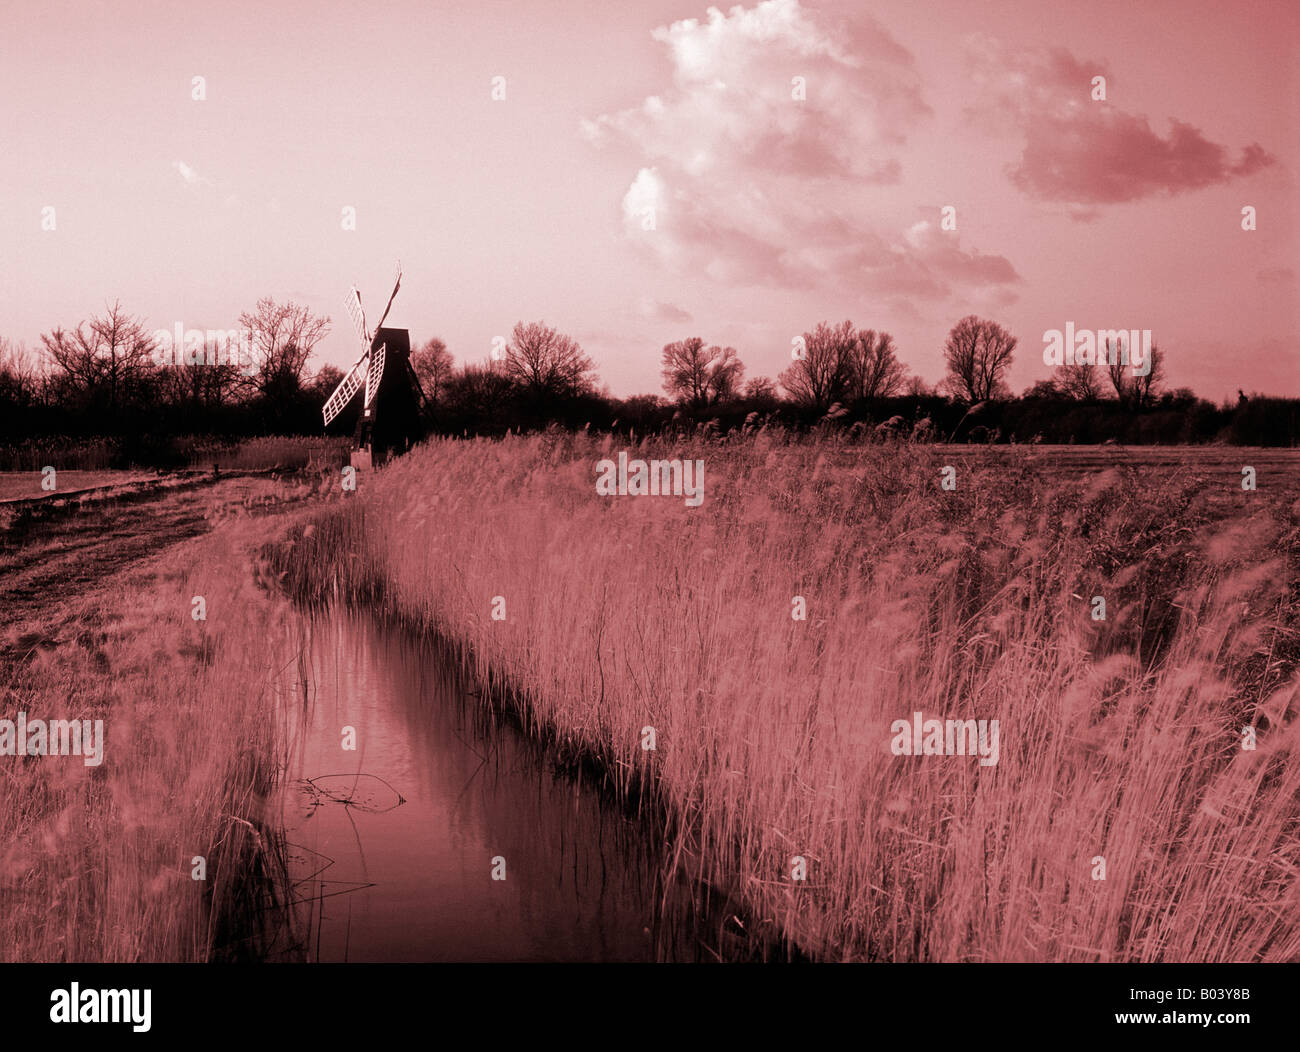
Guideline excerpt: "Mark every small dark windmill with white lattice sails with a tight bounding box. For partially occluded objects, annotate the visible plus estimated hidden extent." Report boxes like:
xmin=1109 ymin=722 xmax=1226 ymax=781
xmin=321 ymin=261 xmax=425 ymax=468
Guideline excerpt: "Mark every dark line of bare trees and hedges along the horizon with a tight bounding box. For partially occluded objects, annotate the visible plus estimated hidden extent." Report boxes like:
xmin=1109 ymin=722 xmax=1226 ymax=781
xmin=0 ymin=298 xmax=1300 ymax=445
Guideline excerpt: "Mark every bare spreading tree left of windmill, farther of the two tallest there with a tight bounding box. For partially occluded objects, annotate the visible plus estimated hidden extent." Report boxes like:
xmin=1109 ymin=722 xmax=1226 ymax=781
xmin=40 ymin=302 xmax=157 ymax=412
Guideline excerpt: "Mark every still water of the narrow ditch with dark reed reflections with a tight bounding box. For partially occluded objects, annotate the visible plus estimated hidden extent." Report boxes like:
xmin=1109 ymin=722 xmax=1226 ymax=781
xmin=286 ymin=611 xmax=710 ymax=961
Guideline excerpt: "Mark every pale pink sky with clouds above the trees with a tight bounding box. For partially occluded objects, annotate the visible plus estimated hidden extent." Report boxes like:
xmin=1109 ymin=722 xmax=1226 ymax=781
xmin=0 ymin=0 xmax=1300 ymax=401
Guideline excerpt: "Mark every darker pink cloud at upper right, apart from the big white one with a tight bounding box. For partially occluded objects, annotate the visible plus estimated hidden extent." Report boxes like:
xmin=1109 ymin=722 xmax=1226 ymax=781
xmin=966 ymin=36 xmax=1274 ymax=205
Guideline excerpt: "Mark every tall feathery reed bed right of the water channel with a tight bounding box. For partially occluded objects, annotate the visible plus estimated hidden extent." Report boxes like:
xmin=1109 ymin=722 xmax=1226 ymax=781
xmin=276 ymin=436 xmax=1300 ymax=961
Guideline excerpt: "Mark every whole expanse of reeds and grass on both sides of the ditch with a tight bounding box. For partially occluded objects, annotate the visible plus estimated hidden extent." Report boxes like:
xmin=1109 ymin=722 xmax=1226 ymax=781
xmin=0 ymin=433 xmax=1300 ymax=961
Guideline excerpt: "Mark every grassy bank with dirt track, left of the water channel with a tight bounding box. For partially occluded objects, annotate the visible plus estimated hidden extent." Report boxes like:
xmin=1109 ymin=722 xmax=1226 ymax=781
xmin=0 ymin=480 xmax=325 ymax=961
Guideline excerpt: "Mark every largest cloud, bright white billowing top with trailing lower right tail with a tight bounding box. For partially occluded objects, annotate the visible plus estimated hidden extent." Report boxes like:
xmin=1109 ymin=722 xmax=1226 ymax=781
xmin=581 ymin=0 xmax=1019 ymax=298
